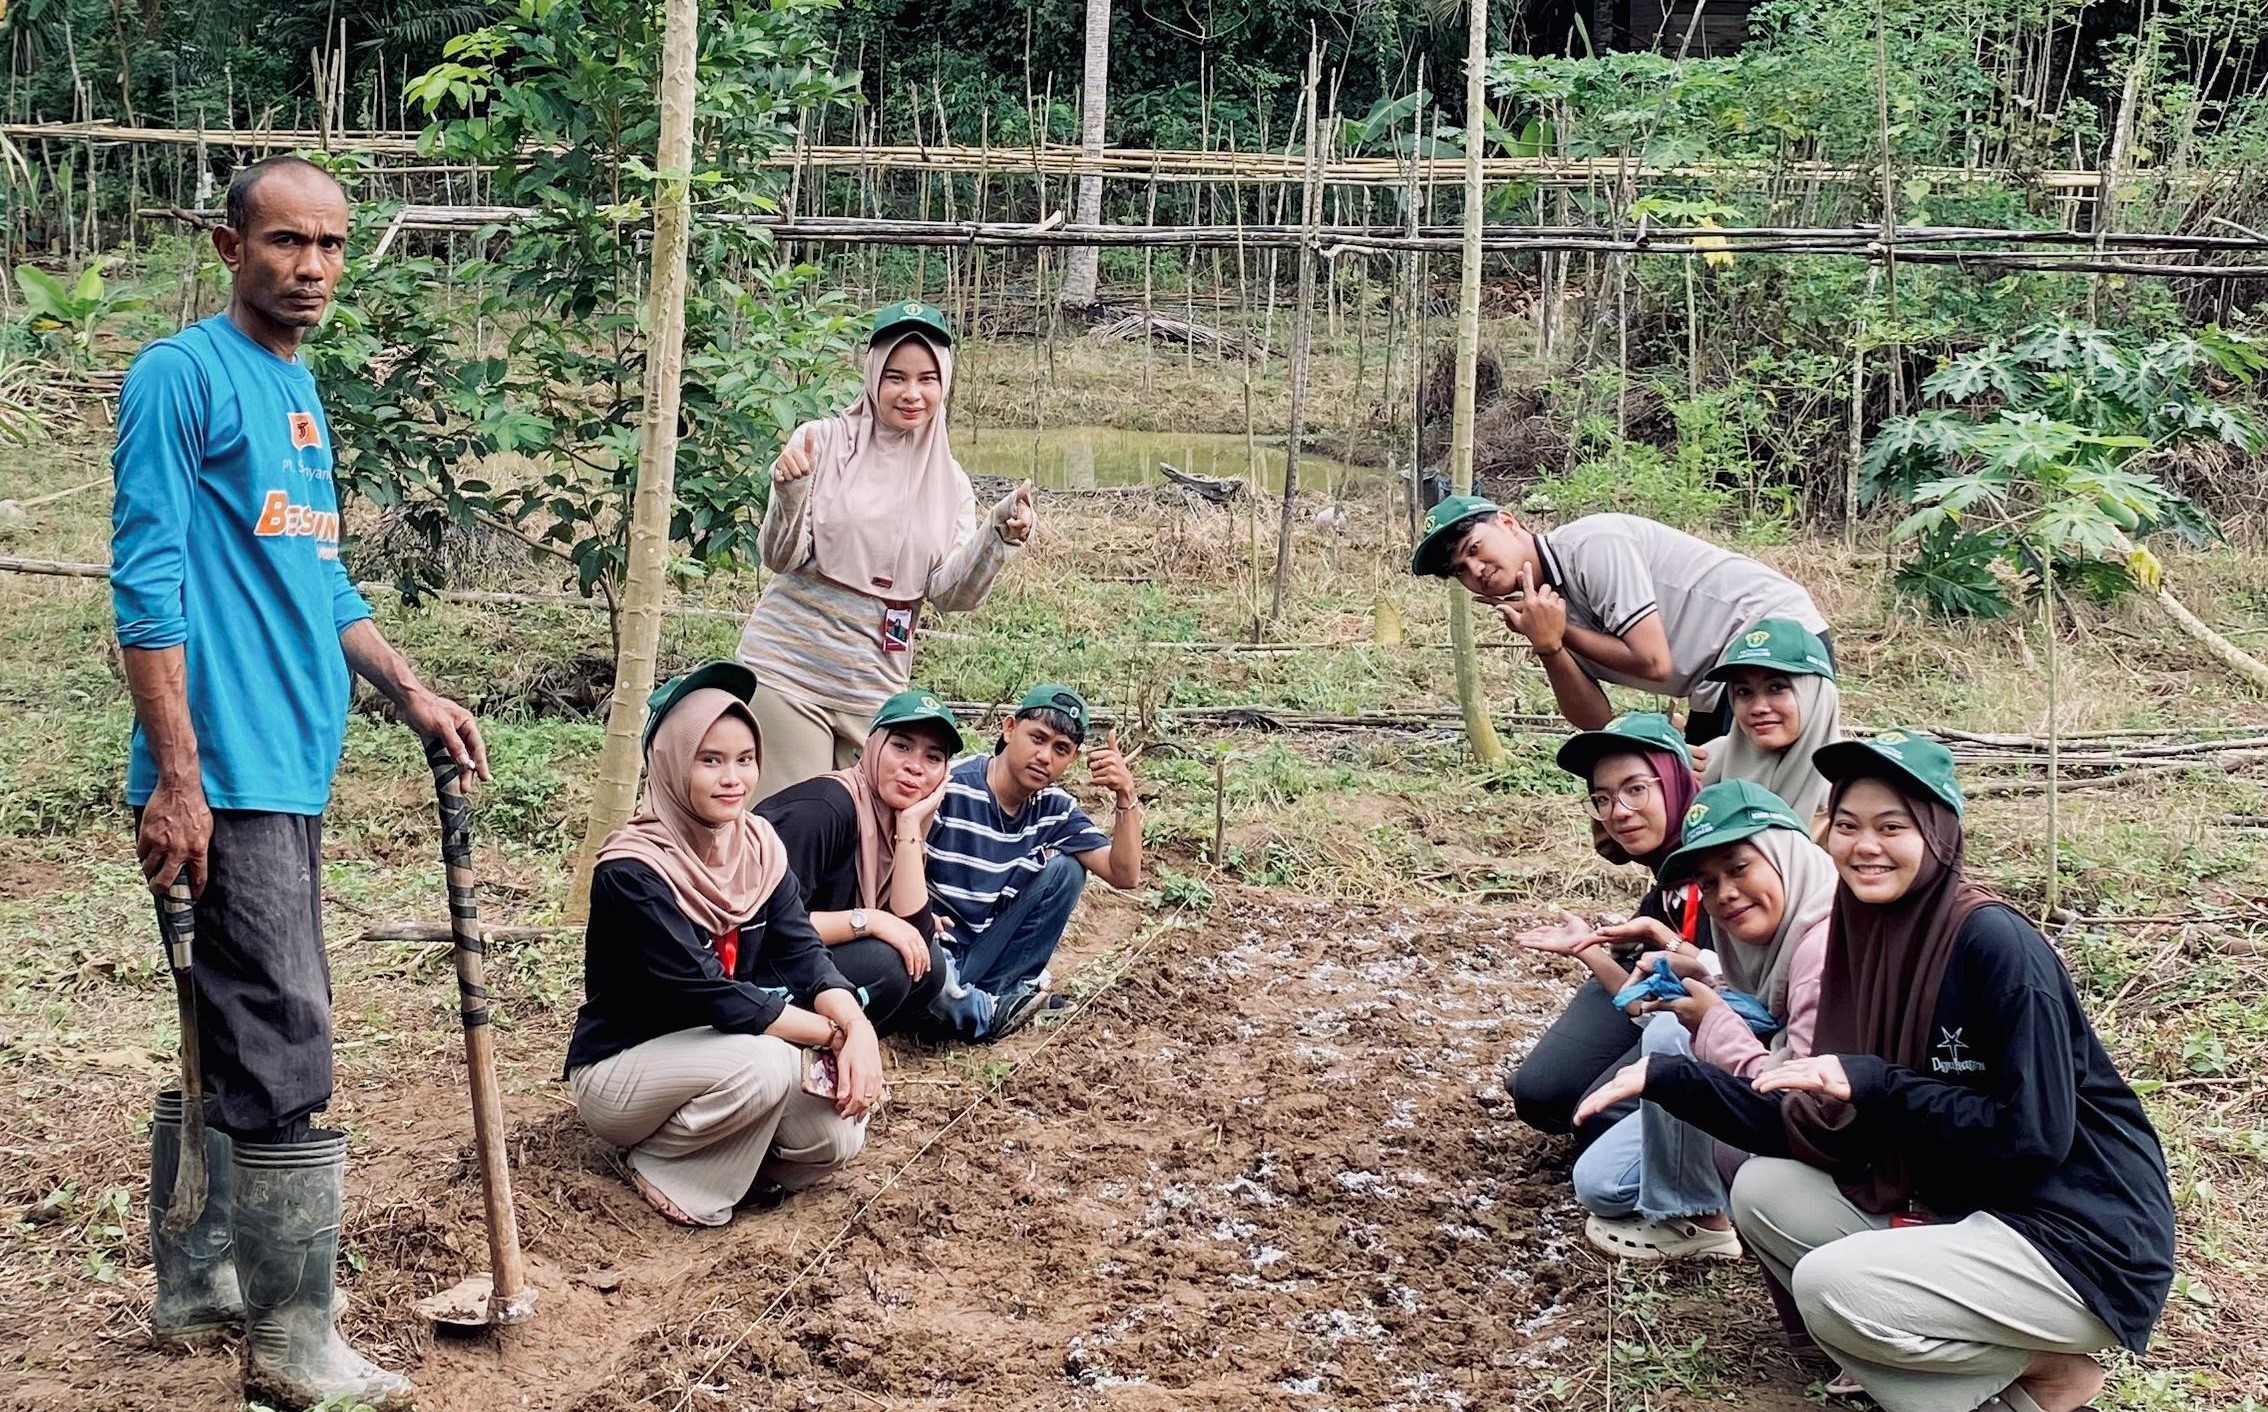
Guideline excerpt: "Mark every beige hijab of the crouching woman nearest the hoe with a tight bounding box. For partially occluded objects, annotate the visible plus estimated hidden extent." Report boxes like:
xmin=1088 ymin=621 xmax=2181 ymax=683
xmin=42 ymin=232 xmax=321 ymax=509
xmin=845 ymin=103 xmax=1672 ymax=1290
xmin=599 ymin=687 xmax=787 ymax=938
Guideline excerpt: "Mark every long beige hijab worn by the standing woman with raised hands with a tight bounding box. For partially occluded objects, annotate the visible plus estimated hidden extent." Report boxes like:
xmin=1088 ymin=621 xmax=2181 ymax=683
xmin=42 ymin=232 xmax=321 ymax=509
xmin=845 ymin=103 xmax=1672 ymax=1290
xmin=812 ymin=333 xmax=971 ymax=603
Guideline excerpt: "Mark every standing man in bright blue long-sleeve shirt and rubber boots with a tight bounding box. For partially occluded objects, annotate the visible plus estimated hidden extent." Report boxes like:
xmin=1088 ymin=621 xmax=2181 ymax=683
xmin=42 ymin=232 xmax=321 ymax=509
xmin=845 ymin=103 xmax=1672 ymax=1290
xmin=111 ymin=156 xmax=488 ymax=1407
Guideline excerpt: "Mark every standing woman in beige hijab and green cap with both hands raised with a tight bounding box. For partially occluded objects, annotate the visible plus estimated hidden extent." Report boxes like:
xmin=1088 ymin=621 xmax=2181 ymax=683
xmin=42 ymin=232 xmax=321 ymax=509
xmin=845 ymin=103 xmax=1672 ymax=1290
xmin=739 ymin=301 xmax=1039 ymax=798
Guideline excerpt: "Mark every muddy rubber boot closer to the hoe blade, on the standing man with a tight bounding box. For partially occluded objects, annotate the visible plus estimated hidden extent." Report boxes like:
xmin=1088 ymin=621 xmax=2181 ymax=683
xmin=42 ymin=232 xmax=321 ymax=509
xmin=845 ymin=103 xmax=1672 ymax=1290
xmin=236 ymin=1129 xmax=415 ymax=1410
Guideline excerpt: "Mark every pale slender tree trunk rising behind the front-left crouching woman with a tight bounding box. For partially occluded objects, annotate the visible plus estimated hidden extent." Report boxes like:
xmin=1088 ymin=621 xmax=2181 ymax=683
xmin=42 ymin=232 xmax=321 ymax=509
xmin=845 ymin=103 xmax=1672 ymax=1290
xmin=567 ymin=0 xmax=699 ymax=920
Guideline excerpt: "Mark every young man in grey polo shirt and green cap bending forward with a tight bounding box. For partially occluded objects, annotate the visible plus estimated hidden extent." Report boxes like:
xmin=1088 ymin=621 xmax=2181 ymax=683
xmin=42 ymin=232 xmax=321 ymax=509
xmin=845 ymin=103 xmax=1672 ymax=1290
xmin=1411 ymin=496 xmax=1835 ymax=743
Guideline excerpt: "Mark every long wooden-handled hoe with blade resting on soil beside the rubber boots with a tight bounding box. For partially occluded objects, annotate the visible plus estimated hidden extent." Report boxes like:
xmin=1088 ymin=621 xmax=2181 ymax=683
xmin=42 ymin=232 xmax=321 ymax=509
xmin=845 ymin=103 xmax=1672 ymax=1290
xmin=417 ymin=741 xmax=535 ymax=1328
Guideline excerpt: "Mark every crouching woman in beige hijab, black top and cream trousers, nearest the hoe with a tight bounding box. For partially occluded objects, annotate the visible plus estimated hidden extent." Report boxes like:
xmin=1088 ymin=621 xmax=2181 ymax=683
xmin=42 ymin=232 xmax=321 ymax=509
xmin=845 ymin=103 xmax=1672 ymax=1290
xmin=567 ymin=662 xmax=882 ymax=1226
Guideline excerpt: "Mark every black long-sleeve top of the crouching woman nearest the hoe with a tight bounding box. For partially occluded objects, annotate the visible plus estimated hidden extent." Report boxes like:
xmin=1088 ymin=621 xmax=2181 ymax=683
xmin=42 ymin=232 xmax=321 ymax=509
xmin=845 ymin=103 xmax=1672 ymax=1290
xmin=567 ymin=859 xmax=853 ymax=1070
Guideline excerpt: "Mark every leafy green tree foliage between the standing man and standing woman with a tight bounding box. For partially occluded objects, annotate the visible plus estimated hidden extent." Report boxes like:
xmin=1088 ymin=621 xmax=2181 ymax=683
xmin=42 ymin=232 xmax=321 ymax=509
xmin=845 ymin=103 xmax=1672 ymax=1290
xmin=313 ymin=0 xmax=848 ymax=592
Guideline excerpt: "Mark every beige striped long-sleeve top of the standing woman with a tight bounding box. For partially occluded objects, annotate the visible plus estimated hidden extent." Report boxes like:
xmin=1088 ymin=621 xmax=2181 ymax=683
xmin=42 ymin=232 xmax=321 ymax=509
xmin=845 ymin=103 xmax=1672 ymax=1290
xmin=739 ymin=476 xmax=1021 ymax=714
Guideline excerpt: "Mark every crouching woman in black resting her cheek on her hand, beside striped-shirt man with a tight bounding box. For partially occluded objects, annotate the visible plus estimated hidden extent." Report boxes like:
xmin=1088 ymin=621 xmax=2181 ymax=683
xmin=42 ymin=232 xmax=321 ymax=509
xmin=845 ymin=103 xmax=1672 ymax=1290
xmin=755 ymin=687 xmax=962 ymax=1034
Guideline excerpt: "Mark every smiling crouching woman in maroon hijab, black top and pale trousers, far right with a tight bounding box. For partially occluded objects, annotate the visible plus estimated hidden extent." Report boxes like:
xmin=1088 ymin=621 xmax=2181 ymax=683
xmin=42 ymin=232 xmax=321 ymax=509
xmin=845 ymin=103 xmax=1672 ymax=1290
xmin=1578 ymin=730 xmax=2173 ymax=1412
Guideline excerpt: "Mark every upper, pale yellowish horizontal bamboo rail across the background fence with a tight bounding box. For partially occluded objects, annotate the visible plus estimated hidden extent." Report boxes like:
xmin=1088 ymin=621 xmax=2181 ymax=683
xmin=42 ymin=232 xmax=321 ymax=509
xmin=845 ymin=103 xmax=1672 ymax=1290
xmin=0 ymin=122 xmax=2159 ymax=197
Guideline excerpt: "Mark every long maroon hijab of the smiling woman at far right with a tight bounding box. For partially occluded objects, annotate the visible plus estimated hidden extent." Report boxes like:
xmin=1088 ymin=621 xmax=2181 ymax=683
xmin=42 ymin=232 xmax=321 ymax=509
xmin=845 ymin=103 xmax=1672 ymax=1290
xmin=1780 ymin=775 xmax=2000 ymax=1213
